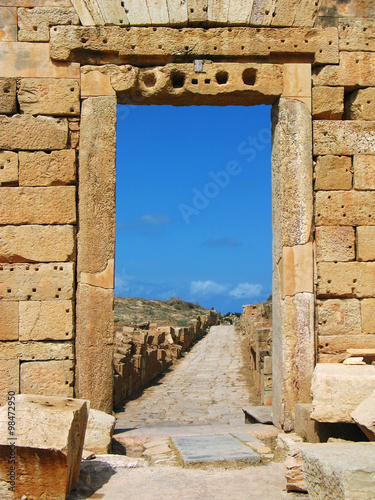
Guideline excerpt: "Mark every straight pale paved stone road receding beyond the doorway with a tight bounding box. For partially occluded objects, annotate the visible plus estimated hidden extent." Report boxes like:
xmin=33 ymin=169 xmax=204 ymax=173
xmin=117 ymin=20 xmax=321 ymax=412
xmin=117 ymin=326 xmax=251 ymax=427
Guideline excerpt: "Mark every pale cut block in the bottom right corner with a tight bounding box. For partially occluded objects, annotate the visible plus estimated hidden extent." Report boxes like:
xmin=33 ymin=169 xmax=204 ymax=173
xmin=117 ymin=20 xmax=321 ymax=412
xmin=301 ymin=443 xmax=375 ymax=500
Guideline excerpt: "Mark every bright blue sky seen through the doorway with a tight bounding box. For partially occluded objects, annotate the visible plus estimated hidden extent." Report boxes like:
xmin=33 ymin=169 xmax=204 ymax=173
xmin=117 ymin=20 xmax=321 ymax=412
xmin=115 ymin=106 xmax=272 ymax=314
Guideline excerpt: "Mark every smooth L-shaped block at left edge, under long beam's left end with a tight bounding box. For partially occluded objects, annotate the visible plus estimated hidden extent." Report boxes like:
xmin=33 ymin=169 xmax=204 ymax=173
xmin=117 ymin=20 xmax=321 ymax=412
xmin=0 ymin=42 xmax=80 ymax=78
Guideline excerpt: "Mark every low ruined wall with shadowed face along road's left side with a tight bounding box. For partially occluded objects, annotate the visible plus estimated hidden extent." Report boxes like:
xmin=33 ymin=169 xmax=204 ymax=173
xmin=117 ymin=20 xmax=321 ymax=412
xmin=113 ymin=311 xmax=219 ymax=407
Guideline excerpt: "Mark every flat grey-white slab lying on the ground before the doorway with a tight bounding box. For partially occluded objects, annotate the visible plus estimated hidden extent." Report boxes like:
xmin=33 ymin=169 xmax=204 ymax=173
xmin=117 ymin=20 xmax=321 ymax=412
xmin=172 ymin=434 xmax=260 ymax=465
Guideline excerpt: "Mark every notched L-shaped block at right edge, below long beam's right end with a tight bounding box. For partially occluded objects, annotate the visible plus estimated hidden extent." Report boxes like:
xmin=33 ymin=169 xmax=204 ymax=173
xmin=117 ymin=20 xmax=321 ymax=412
xmin=313 ymin=52 xmax=375 ymax=88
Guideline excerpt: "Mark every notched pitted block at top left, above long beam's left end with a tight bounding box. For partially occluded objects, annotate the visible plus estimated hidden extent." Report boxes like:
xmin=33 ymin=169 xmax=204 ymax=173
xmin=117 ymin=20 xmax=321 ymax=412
xmin=18 ymin=7 xmax=79 ymax=42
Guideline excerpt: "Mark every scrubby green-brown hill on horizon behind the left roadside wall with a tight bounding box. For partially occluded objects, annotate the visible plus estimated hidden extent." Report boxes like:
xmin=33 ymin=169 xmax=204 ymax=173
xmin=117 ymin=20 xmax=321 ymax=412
xmin=115 ymin=297 xmax=217 ymax=330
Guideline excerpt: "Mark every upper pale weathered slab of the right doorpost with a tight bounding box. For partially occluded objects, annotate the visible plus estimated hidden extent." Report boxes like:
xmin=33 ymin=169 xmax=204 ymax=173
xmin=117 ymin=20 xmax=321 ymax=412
xmin=272 ymin=98 xmax=313 ymax=263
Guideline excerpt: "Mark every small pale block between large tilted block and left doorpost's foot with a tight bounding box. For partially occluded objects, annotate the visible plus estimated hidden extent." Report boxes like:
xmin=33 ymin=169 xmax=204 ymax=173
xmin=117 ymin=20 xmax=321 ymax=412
xmin=84 ymin=408 xmax=116 ymax=454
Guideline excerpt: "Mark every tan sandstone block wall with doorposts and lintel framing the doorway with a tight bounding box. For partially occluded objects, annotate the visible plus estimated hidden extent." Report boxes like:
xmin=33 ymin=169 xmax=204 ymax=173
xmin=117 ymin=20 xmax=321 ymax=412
xmin=0 ymin=0 xmax=375 ymax=429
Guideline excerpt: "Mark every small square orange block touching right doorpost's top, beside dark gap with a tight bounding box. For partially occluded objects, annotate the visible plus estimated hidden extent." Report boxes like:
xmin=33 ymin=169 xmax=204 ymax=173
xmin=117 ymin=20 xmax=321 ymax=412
xmin=312 ymin=86 xmax=344 ymax=120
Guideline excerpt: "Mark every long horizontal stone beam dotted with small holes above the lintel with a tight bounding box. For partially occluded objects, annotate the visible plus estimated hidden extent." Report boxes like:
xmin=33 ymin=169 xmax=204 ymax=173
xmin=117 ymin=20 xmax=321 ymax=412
xmin=51 ymin=25 xmax=338 ymax=65
